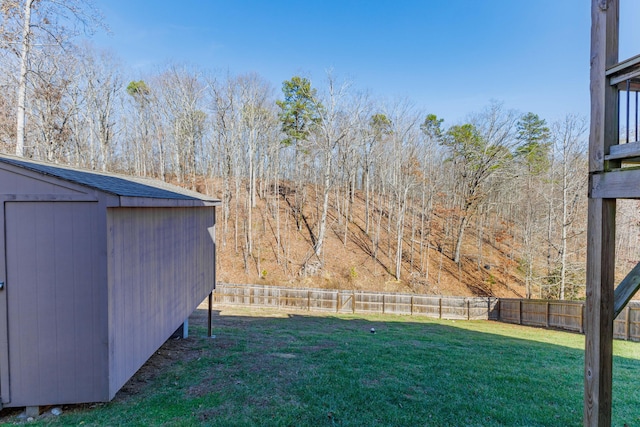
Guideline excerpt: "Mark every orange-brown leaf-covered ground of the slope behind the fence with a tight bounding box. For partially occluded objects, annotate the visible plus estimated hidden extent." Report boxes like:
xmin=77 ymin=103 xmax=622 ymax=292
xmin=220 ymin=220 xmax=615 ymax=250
xmin=205 ymin=177 xmax=524 ymax=297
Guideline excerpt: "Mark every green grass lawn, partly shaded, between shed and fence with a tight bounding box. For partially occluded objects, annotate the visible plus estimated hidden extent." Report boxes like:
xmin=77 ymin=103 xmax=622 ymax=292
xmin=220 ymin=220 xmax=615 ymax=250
xmin=3 ymin=307 xmax=640 ymax=426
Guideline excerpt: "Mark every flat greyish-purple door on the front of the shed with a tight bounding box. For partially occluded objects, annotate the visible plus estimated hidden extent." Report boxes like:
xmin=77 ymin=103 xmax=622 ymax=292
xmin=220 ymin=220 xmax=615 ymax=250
xmin=0 ymin=202 xmax=99 ymax=406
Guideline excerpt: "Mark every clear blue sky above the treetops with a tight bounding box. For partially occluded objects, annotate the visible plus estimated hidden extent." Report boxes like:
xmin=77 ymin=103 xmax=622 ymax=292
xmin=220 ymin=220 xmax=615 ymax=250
xmin=94 ymin=0 xmax=640 ymax=125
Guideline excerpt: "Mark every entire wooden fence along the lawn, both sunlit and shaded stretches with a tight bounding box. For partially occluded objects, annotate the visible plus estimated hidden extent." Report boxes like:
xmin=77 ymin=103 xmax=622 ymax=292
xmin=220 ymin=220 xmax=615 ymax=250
xmin=213 ymin=283 xmax=640 ymax=341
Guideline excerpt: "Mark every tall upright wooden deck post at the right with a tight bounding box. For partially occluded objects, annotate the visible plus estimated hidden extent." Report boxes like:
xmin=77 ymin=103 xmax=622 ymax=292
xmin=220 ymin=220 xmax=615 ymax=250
xmin=583 ymin=0 xmax=619 ymax=427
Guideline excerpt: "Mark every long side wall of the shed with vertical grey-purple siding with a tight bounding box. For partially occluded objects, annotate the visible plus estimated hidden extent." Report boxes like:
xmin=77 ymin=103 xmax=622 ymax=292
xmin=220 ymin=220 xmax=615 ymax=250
xmin=107 ymin=208 xmax=215 ymax=397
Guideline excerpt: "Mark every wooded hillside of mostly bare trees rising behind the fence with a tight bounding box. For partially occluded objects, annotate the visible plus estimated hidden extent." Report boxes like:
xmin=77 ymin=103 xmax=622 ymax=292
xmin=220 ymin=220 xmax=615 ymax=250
xmin=0 ymin=2 xmax=640 ymax=299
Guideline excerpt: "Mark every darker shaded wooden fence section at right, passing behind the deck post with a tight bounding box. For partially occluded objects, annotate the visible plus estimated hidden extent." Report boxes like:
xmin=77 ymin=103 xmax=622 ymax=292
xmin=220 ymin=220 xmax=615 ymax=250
xmin=496 ymin=298 xmax=640 ymax=341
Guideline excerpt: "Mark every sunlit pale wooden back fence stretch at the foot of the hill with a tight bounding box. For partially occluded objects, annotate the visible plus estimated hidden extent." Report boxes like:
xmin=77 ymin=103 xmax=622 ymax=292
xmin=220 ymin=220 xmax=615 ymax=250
xmin=213 ymin=284 xmax=498 ymax=320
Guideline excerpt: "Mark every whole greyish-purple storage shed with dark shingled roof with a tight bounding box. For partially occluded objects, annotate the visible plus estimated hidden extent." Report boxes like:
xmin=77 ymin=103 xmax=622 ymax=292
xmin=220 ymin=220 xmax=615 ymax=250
xmin=0 ymin=155 xmax=220 ymax=407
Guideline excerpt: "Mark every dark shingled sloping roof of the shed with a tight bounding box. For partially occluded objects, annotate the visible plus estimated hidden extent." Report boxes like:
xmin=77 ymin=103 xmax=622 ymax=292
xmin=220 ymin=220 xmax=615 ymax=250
xmin=0 ymin=155 xmax=220 ymax=206
